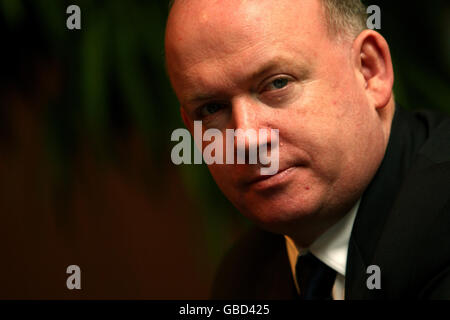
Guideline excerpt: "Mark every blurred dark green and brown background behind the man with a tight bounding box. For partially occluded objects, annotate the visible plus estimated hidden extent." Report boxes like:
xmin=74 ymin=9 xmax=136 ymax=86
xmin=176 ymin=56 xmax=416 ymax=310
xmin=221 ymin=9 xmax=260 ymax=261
xmin=0 ymin=0 xmax=450 ymax=299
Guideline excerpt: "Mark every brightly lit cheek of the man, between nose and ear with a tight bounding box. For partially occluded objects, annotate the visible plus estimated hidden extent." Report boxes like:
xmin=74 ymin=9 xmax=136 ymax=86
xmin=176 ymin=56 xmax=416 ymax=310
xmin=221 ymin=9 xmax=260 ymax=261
xmin=280 ymin=94 xmax=363 ymax=189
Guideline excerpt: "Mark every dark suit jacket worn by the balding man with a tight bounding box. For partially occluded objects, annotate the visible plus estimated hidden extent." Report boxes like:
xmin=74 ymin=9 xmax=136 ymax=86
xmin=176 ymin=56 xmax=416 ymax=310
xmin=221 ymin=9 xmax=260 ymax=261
xmin=212 ymin=107 xmax=450 ymax=299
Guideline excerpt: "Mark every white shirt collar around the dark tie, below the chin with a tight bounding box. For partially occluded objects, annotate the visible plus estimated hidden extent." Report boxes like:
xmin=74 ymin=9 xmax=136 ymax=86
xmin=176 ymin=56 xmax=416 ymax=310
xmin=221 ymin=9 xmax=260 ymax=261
xmin=285 ymin=199 xmax=361 ymax=279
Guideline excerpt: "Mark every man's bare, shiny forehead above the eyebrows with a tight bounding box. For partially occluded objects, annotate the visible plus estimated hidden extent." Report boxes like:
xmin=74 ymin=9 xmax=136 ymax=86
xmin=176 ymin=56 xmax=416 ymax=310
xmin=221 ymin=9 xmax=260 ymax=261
xmin=166 ymin=0 xmax=327 ymax=97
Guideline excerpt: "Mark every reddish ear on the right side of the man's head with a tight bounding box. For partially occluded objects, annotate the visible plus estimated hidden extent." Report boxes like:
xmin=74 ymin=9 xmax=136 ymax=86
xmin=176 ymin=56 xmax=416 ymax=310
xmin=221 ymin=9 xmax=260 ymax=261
xmin=352 ymin=30 xmax=394 ymax=109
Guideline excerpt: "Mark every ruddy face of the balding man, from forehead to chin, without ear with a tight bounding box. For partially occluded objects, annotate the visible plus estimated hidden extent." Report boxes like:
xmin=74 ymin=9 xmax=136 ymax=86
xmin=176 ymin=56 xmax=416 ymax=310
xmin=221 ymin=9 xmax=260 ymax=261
xmin=166 ymin=0 xmax=385 ymax=238
